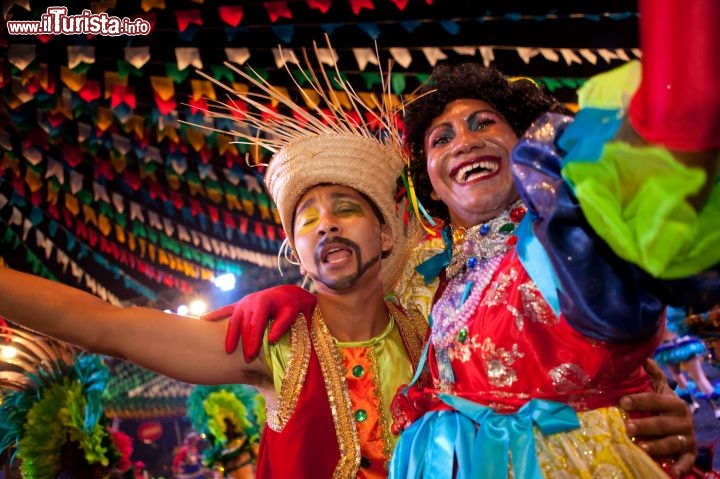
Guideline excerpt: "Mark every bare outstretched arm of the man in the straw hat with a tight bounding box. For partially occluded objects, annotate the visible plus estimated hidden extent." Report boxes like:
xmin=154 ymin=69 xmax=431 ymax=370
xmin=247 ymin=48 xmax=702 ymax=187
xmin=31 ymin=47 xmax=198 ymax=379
xmin=0 ymin=268 xmax=269 ymax=386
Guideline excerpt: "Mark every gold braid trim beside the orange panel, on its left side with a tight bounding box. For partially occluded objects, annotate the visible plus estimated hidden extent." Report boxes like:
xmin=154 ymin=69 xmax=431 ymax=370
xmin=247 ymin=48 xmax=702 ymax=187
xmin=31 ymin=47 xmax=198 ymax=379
xmin=310 ymin=306 xmax=360 ymax=479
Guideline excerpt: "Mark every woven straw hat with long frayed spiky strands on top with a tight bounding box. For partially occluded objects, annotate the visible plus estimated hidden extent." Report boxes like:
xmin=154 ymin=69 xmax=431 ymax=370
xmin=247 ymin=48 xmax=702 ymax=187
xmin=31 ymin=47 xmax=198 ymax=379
xmin=200 ymin=39 xmax=421 ymax=292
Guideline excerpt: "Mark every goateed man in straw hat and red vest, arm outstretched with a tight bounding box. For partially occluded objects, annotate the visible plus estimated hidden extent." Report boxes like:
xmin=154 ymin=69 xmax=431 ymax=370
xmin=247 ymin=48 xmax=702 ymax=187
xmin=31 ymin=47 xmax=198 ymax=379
xmin=0 ymin=47 xmax=427 ymax=478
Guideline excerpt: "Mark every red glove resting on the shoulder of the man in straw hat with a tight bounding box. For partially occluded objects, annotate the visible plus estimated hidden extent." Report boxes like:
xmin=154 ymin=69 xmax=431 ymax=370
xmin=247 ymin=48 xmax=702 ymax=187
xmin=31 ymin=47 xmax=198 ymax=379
xmin=202 ymin=284 xmax=317 ymax=363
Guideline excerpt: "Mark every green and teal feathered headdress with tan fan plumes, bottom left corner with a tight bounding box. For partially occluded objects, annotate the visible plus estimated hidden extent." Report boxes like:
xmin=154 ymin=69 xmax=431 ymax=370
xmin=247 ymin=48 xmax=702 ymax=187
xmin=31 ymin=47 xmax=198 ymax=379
xmin=0 ymin=320 xmax=129 ymax=479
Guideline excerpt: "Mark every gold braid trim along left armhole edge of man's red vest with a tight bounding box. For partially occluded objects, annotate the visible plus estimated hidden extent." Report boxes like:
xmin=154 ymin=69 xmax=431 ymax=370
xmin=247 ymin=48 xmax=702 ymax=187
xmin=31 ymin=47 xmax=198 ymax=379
xmin=265 ymin=314 xmax=310 ymax=432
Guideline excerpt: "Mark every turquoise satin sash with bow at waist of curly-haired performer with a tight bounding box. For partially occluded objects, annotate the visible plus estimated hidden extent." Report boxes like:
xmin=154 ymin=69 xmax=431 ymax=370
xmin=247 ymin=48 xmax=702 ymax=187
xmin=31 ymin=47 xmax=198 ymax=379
xmin=390 ymin=394 xmax=580 ymax=479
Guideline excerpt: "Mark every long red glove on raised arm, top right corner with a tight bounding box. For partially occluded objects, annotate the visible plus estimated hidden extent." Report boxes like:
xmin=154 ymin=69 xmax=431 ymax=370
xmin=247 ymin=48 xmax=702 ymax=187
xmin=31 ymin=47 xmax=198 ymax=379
xmin=629 ymin=0 xmax=720 ymax=152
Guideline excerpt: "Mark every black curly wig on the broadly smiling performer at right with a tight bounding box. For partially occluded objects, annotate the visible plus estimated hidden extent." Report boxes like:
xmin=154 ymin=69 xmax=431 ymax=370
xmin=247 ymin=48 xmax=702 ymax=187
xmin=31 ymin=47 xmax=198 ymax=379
xmin=404 ymin=61 xmax=569 ymax=222
